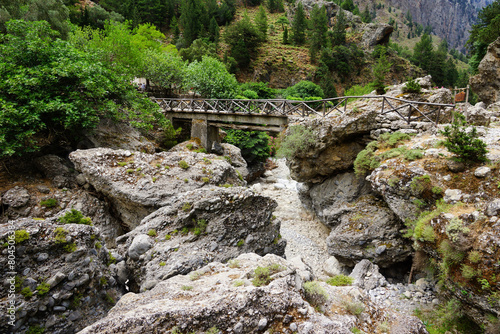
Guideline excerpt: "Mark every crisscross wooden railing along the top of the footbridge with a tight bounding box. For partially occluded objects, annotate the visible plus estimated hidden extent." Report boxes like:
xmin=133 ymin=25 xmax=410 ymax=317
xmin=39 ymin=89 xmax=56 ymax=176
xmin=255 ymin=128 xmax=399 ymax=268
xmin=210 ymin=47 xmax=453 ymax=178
xmin=153 ymin=95 xmax=455 ymax=125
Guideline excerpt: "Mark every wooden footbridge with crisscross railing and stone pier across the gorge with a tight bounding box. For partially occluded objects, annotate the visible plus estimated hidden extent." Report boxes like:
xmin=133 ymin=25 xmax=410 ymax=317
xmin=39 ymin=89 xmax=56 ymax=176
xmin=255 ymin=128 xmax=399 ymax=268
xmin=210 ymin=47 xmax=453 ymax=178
xmin=153 ymin=95 xmax=455 ymax=150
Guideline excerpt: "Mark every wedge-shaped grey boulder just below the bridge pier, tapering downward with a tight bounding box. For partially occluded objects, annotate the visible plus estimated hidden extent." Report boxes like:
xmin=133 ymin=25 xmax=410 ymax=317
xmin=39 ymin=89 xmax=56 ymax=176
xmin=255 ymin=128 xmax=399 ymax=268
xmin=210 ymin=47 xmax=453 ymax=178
xmin=70 ymin=148 xmax=244 ymax=229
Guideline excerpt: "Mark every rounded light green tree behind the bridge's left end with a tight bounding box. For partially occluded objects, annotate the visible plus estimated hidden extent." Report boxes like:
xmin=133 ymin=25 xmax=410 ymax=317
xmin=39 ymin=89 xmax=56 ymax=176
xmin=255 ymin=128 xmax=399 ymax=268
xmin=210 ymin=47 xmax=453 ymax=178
xmin=184 ymin=56 xmax=238 ymax=99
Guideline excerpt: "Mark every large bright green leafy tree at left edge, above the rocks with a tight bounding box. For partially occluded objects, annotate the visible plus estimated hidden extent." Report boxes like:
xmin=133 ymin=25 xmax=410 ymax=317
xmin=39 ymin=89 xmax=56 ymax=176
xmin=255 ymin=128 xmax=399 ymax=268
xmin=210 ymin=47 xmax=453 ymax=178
xmin=0 ymin=20 xmax=160 ymax=157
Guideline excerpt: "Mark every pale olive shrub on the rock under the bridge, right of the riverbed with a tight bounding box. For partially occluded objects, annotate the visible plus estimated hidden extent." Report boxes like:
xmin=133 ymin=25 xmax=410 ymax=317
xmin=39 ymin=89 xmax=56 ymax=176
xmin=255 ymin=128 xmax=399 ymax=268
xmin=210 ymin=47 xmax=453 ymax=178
xmin=276 ymin=125 xmax=317 ymax=159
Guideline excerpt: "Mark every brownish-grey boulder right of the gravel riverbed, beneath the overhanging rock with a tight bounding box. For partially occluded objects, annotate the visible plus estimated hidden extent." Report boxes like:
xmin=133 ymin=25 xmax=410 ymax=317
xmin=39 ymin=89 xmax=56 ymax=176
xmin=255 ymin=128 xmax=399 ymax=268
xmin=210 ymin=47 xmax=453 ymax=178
xmin=302 ymin=172 xmax=411 ymax=267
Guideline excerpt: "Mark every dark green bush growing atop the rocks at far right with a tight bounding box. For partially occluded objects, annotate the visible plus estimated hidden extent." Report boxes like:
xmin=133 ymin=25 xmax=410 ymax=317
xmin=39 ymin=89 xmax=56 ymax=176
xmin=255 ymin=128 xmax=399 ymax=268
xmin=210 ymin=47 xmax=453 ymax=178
xmin=441 ymin=113 xmax=488 ymax=162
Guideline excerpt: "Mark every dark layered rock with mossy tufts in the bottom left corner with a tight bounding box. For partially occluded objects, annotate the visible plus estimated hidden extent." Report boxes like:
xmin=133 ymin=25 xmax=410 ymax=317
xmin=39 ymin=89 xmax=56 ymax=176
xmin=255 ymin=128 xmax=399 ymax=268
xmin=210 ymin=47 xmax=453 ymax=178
xmin=0 ymin=218 xmax=121 ymax=333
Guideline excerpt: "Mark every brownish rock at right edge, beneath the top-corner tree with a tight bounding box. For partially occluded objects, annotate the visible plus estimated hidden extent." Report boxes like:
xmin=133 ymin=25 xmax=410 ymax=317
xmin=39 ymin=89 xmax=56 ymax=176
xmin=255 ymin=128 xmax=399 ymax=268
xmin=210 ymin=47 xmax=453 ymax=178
xmin=469 ymin=37 xmax=500 ymax=105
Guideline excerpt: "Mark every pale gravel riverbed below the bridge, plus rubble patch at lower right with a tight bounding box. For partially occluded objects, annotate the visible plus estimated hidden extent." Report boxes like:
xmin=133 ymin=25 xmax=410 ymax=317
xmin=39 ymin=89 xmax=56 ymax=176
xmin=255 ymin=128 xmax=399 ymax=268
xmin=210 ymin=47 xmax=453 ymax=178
xmin=252 ymin=159 xmax=439 ymax=315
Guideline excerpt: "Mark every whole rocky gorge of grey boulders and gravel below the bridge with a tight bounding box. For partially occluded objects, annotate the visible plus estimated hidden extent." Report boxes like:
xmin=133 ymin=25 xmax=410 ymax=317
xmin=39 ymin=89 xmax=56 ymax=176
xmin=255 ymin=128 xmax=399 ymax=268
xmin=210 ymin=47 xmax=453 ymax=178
xmin=0 ymin=40 xmax=500 ymax=334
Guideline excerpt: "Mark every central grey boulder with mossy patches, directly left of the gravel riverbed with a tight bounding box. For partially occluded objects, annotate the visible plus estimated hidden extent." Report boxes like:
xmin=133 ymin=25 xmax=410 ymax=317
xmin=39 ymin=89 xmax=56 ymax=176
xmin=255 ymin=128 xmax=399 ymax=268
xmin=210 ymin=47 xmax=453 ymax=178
xmin=112 ymin=187 xmax=286 ymax=291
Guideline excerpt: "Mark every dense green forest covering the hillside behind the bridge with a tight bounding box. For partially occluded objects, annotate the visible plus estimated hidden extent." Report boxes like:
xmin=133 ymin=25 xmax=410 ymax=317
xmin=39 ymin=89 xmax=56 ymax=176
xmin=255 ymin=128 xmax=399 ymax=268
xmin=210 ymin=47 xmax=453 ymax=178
xmin=0 ymin=0 xmax=500 ymax=157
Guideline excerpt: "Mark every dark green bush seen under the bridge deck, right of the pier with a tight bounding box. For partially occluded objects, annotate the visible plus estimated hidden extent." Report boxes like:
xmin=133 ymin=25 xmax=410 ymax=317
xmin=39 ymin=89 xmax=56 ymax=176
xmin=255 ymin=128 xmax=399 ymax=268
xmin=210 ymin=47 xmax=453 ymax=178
xmin=224 ymin=129 xmax=271 ymax=164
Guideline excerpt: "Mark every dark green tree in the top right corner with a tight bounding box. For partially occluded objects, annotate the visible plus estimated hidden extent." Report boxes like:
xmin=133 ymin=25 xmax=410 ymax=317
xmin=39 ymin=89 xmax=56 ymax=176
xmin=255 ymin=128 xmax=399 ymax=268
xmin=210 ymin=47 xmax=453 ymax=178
xmin=466 ymin=0 xmax=500 ymax=72
